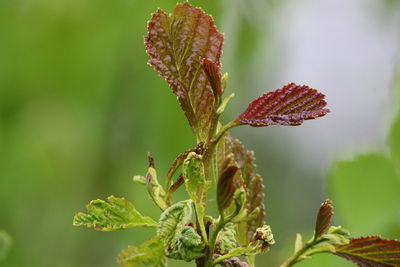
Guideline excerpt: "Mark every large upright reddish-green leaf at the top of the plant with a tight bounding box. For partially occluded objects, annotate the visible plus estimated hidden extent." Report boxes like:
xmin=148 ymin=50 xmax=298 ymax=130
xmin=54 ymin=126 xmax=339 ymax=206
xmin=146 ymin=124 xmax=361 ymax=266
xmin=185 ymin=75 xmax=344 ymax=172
xmin=145 ymin=2 xmax=223 ymax=140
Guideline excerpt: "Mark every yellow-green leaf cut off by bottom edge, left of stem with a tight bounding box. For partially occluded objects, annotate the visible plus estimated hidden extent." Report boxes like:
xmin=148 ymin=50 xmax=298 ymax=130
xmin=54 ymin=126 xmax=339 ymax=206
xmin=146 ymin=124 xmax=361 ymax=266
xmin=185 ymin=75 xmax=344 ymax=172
xmin=117 ymin=237 xmax=167 ymax=267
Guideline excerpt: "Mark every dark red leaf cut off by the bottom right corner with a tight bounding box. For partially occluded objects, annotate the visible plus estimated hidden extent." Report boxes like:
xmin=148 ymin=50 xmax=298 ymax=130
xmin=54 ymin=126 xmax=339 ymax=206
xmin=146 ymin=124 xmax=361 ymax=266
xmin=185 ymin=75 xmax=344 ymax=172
xmin=334 ymin=236 xmax=400 ymax=267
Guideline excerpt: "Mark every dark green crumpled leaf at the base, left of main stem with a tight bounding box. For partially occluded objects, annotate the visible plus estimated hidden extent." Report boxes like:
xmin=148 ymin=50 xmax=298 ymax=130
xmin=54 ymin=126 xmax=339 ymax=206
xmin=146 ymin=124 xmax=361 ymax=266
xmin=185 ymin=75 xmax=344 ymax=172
xmin=166 ymin=226 xmax=205 ymax=261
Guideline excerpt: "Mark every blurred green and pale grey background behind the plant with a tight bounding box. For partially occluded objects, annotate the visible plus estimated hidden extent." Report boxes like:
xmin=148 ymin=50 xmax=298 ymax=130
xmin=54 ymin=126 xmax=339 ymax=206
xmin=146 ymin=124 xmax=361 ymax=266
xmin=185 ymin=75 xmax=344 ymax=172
xmin=0 ymin=0 xmax=400 ymax=267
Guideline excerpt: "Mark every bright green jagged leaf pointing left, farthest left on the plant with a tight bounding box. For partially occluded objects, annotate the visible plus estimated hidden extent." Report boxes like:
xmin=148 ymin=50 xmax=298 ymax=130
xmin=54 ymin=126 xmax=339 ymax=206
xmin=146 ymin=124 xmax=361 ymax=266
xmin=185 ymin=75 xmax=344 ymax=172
xmin=73 ymin=196 xmax=157 ymax=231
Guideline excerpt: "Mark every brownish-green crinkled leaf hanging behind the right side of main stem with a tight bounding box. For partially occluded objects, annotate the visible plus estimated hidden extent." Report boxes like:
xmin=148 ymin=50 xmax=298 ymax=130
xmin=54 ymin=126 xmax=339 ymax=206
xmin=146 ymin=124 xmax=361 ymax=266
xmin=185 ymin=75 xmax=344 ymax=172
xmin=218 ymin=134 xmax=265 ymax=244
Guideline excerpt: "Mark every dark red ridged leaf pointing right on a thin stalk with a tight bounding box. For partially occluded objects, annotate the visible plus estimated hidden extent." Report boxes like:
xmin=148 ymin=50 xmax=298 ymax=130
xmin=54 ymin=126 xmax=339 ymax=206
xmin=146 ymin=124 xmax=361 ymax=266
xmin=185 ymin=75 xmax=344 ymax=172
xmin=236 ymin=83 xmax=329 ymax=126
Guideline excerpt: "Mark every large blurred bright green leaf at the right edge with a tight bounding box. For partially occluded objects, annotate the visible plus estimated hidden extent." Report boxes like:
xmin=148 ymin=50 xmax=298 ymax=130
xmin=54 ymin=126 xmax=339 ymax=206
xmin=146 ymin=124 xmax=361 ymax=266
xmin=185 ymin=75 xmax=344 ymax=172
xmin=330 ymin=154 xmax=400 ymax=237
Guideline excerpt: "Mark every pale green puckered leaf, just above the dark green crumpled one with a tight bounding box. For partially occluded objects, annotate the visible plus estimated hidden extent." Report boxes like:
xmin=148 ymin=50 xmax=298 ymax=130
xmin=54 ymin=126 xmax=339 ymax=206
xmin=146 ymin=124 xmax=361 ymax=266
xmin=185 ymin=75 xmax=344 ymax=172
xmin=157 ymin=199 xmax=193 ymax=246
